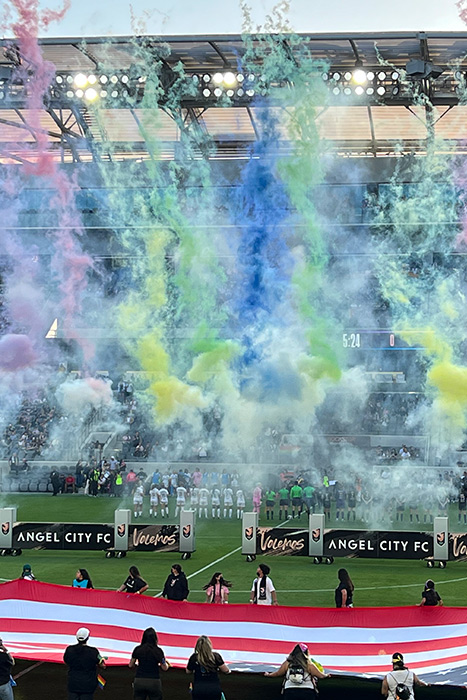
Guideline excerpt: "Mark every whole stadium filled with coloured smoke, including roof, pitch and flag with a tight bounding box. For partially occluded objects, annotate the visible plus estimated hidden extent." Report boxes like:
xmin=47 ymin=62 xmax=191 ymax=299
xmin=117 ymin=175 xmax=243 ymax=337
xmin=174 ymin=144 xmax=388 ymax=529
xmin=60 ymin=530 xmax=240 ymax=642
xmin=0 ymin=2 xmax=467 ymax=700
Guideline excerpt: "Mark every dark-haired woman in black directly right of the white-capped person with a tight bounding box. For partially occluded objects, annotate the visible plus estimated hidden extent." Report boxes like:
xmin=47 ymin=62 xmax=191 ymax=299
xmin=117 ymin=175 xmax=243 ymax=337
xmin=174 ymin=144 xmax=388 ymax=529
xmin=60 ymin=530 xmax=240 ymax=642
xmin=128 ymin=627 xmax=169 ymax=700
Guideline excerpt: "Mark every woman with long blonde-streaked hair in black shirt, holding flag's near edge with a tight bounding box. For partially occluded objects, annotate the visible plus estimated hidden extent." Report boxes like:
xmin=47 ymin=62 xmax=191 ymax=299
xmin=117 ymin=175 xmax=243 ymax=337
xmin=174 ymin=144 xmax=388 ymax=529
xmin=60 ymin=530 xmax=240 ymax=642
xmin=186 ymin=635 xmax=230 ymax=700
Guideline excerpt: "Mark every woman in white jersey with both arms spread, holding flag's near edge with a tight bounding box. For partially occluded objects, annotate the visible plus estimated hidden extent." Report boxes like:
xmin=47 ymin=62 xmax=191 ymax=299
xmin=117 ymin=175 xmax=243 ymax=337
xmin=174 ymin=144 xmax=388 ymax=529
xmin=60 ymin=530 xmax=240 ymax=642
xmin=264 ymin=644 xmax=330 ymax=700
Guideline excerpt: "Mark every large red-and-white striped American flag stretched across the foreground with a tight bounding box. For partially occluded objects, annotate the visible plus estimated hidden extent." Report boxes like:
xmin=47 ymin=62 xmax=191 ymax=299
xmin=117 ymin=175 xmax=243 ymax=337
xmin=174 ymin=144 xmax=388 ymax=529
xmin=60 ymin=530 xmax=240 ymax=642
xmin=0 ymin=579 xmax=467 ymax=685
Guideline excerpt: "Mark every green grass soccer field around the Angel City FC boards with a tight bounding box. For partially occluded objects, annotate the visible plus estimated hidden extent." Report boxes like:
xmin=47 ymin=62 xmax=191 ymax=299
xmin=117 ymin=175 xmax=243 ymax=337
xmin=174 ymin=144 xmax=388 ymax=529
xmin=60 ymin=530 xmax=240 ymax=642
xmin=0 ymin=494 xmax=467 ymax=607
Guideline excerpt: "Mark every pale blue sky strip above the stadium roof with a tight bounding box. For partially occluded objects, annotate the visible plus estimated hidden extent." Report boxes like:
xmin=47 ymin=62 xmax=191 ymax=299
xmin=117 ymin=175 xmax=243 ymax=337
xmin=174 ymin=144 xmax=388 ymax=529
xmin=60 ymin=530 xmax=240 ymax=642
xmin=33 ymin=0 xmax=467 ymax=37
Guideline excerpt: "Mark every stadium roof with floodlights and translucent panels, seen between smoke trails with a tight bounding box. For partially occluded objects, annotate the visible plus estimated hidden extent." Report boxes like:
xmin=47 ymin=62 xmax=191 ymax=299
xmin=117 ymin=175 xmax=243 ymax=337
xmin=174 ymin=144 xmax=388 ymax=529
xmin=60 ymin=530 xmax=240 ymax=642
xmin=0 ymin=32 xmax=467 ymax=164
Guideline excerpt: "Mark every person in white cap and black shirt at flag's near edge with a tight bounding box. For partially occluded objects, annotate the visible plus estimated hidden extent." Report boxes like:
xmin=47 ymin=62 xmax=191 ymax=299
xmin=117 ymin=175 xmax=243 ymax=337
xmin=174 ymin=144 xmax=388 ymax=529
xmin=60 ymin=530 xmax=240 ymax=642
xmin=63 ymin=627 xmax=105 ymax=700
